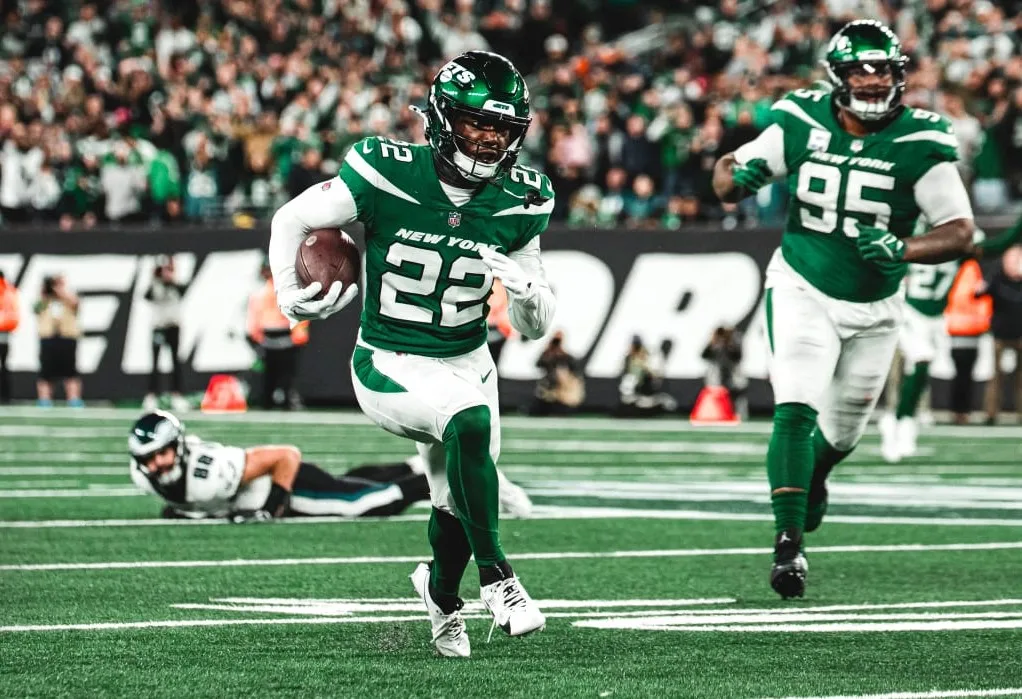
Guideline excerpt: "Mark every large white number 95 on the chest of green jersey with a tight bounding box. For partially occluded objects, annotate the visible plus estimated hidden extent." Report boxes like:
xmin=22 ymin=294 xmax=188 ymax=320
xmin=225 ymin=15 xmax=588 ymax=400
xmin=795 ymin=160 xmax=894 ymax=238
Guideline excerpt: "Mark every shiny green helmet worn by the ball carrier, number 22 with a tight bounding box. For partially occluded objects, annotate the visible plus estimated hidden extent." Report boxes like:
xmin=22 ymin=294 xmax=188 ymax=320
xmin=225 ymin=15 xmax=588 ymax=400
xmin=425 ymin=51 xmax=532 ymax=182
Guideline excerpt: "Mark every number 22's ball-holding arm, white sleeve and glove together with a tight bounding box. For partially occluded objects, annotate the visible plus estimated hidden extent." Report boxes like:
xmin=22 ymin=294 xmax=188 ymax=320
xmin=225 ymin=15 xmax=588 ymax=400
xmin=269 ymin=177 xmax=359 ymax=321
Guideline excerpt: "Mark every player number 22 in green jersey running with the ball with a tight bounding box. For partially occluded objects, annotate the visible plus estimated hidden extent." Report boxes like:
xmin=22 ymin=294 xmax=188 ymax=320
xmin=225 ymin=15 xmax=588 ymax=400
xmin=270 ymin=51 xmax=554 ymax=657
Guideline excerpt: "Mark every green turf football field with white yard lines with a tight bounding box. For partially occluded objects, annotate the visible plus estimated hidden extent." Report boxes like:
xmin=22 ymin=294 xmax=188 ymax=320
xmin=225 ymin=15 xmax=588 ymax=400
xmin=0 ymin=409 xmax=1022 ymax=699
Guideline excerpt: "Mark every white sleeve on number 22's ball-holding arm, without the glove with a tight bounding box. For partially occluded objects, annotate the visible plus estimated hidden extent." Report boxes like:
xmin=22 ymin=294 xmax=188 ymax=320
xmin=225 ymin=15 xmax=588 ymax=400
xmin=270 ymin=177 xmax=358 ymax=292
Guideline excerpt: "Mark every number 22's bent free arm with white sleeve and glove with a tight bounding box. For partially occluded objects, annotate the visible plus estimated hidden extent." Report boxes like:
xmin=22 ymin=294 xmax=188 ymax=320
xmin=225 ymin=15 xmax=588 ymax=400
xmin=479 ymin=238 xmax=557 ymax=339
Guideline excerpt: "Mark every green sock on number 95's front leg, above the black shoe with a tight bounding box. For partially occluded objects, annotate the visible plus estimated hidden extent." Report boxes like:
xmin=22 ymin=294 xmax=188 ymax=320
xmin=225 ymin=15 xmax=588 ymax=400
xmin=767 ymin=403 xmax=817 ymax=532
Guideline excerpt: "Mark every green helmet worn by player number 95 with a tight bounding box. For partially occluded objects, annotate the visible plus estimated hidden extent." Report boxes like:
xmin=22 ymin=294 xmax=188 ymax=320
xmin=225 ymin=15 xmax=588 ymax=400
xmin=823 ymin=19 xmax=909 ymax=122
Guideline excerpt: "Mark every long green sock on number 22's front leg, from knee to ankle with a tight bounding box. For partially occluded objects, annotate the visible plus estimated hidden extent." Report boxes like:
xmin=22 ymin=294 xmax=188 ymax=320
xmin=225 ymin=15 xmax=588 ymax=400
xmin=444 ymin=406 xmax=506 ymax=567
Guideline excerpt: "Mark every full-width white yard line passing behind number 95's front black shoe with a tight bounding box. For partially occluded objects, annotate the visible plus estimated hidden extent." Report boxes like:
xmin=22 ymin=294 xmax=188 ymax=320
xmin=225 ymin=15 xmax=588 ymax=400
xmin=0 ymin=542 xmax=1022 ymax=571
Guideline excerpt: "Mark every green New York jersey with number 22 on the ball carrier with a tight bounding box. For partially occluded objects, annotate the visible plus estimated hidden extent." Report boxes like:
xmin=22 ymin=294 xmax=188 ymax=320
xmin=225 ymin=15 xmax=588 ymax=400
xmin=339 ymin=137 xmax=554 ymax=357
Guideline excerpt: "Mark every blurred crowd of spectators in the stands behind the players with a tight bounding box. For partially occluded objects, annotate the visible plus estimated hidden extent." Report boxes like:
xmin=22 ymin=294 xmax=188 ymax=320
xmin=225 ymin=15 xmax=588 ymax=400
xmin=0 ymin=0 xmax=1022 ymax=230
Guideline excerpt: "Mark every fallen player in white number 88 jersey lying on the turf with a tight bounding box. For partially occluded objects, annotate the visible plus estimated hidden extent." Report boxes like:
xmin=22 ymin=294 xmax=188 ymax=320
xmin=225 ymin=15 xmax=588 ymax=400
xmin=128 ymin=411 xmax=531 ymax=523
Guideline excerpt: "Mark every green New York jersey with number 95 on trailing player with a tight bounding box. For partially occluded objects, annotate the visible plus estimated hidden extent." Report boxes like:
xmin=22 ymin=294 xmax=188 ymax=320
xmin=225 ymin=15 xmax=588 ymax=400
xmin=773 ymin=90 xmax=958 ymax=301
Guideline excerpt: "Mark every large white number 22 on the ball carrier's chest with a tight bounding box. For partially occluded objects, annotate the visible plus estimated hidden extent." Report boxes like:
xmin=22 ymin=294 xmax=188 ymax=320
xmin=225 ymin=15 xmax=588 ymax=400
xmin=380 ymin=242 xmax=494 ymax=328
